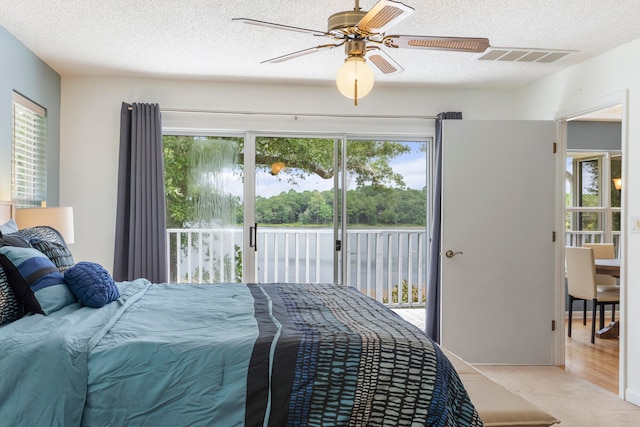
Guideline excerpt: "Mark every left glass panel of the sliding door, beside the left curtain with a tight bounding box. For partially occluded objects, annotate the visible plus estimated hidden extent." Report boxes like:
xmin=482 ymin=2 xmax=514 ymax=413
xmin=163 ymin=135 xmax=244 ymax=283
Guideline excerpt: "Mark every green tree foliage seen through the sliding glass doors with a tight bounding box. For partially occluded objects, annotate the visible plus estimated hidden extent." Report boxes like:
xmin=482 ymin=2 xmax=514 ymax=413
xmin=163 ymin=135 xmax=426 ymax=228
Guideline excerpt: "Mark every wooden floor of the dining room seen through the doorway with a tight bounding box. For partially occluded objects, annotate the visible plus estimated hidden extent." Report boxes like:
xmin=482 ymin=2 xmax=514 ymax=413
xmin=564 ymin=316 xmax=619 ymax=394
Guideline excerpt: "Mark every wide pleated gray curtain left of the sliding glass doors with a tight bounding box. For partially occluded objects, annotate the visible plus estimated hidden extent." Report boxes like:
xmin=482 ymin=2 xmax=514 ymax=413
xmin=113 ymin=103 xmax=167 ymax=283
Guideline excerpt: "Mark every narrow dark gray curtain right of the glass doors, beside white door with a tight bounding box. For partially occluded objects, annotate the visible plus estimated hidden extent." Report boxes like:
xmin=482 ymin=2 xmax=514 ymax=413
xmin=425 ymin=112 xmax=462 ymax=344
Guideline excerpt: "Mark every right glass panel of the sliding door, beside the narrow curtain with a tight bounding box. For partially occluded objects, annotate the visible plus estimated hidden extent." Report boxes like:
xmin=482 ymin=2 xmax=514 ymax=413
xmin=344 ymin=140 xmax=428 ymax=306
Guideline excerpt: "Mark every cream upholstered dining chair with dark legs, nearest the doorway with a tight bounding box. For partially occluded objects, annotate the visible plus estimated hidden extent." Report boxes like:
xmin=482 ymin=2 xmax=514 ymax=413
xmin=565 ymin=246 xmax=620 ymax=344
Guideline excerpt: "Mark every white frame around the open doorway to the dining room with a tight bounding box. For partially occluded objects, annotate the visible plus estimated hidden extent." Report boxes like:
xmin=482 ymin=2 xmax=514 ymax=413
xmin=554 ymin=90 xmax=629 ymax=400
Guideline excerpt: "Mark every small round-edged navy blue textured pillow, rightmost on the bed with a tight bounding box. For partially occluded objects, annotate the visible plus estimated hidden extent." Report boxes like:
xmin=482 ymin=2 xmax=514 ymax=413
xmin=64 ymin=261 xmax=120 ymax=308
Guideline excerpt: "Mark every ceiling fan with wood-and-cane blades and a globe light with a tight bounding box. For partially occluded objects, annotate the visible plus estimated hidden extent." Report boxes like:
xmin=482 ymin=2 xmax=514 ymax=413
xmin=232 ymin=0 xmax=489 ymax=105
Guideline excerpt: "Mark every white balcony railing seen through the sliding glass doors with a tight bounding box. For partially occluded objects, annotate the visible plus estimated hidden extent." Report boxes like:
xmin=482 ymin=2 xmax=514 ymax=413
xmin=166 ymin=227 xmax=427 ymax=307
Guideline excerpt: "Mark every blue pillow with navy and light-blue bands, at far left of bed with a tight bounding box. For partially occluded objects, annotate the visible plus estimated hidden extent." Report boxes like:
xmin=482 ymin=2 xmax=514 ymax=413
xmin=0 ymin=246 xmax=76 ymax=315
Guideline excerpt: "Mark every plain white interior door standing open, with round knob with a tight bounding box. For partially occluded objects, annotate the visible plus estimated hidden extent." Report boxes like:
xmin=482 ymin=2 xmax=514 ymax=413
xmin=440 ymin=120 xmax=562 ymax=365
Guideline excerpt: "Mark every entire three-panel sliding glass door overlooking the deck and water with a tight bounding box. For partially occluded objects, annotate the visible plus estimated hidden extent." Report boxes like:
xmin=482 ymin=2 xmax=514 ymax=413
xmin=164 ymin=133 xmax=429 ymax=300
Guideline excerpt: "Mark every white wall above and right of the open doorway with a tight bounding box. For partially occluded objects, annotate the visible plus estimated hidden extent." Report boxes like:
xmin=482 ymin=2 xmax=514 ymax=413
xmin=515 ymin=36 xmax=640 ymax=405
